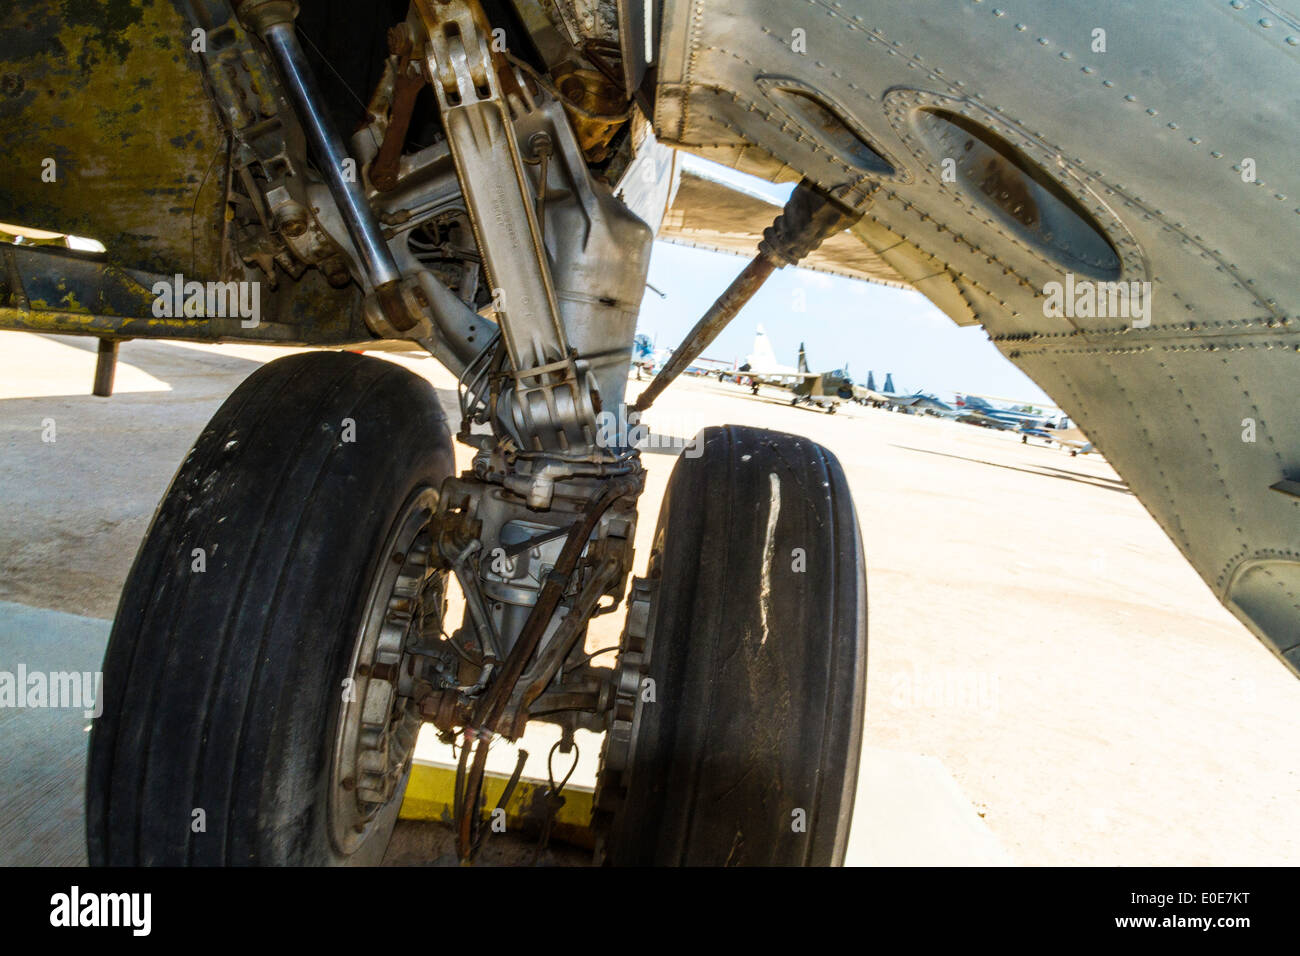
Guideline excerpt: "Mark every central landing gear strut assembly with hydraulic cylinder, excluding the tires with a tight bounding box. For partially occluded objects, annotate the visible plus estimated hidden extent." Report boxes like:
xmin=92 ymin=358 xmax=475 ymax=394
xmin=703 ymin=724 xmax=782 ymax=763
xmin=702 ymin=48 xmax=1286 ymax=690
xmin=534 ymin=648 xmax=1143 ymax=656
xmin=226 ymin=0 xmax=653 ymax=858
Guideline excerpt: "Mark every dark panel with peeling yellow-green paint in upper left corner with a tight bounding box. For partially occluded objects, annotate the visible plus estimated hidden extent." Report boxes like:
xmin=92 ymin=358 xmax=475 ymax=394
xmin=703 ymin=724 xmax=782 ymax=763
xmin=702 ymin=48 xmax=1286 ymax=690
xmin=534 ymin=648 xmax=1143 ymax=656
xmin=0 ymin=0 xmax=225 ymax=278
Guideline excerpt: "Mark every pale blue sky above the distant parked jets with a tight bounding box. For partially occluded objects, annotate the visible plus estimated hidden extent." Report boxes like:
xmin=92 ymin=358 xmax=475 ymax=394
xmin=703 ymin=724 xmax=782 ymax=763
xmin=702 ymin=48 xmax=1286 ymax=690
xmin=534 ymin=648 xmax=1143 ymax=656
xmin=637 ymin=157 xmax=1048 ymax=403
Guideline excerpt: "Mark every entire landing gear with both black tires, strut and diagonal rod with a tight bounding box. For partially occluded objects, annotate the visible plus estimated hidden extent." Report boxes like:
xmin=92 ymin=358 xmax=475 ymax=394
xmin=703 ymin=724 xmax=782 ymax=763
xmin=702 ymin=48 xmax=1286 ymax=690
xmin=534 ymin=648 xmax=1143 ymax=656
xmin=87 ymin=0 xmax=866 ymax=865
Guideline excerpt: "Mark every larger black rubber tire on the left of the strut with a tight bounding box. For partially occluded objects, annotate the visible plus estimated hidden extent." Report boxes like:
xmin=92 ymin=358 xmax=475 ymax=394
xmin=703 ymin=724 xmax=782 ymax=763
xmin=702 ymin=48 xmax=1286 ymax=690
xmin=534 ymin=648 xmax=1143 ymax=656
xmin=86 ymin=352 xmax=454 ymax=865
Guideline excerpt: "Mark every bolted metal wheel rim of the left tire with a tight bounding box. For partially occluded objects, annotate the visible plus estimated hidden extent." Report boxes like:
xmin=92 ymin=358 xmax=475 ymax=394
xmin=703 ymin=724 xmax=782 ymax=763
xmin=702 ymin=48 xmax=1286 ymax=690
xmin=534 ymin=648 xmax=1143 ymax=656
xmin=328 ymin=488 xmax=443 ymax=856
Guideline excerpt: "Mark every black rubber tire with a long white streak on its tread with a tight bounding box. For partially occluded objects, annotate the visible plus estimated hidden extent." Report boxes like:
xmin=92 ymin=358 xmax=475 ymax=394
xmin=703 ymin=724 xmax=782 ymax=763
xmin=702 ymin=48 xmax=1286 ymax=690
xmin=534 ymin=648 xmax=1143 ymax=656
xmin=602 ymin=425 xmax=867 ymax=866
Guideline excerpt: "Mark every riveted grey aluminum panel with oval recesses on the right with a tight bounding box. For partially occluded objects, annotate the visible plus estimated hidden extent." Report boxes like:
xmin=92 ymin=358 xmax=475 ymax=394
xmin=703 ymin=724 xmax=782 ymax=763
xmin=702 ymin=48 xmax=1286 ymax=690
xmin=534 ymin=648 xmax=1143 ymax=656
xmin=639 ymin=0 xmax=1300 ymax=671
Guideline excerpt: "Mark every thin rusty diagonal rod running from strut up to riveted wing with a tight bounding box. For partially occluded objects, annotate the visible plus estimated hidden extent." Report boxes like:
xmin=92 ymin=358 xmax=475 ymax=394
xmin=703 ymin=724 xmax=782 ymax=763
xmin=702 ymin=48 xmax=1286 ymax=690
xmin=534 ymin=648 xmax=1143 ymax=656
xmin=634 ymin=179 xmax=863 ymax=411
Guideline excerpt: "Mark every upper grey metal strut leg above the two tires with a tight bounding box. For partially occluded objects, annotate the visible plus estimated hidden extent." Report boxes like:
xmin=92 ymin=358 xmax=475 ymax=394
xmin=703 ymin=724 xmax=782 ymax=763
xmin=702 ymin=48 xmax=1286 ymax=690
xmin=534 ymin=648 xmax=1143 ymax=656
xmin=407 ymin=0 xmax=653 ymax=463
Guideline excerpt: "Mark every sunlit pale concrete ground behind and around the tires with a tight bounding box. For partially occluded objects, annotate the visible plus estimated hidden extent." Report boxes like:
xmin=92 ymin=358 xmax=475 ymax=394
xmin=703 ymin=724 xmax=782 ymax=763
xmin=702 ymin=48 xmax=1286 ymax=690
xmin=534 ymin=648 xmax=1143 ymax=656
xmin=0 ymin=333 xmax=1300 ymax=865
